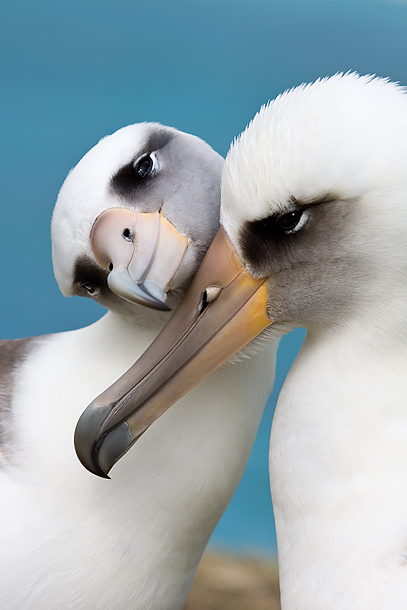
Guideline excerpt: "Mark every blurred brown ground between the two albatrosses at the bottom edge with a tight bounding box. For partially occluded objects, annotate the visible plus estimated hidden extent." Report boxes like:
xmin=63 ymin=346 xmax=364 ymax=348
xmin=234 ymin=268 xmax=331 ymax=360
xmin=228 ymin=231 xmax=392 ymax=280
xmin=184 ymin=552 xmax=280 ymax=610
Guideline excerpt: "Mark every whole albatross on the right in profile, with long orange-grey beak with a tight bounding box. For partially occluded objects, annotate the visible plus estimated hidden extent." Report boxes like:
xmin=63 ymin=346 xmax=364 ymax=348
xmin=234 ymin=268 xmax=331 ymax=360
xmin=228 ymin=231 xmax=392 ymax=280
xmin=77 ymin=73 xmax=407 ymax=610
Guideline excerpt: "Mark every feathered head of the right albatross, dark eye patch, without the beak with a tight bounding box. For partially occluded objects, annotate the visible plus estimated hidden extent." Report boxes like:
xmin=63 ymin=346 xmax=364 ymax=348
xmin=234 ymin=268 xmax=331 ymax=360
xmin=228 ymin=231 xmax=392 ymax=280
xmin=221 ymin=73 xmax=407 ymax=330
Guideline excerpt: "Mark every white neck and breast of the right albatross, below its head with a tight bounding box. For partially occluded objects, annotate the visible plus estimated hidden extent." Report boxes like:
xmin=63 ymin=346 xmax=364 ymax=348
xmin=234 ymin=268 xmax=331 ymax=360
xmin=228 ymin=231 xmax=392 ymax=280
xmin=270 ymin=332 xmax=407 ymax=610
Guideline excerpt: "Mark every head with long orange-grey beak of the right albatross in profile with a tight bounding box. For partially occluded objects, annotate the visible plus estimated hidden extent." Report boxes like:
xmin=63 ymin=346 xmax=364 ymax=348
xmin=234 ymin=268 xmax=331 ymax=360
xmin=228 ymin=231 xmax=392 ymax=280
xmin=76 ymin=74 xmax=407 ymax=475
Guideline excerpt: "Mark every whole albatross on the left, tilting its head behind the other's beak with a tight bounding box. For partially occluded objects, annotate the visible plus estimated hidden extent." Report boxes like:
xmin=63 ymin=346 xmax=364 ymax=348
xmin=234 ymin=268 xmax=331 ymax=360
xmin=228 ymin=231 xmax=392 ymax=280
xmin=0 ymin=123 xmax=275 ymax=610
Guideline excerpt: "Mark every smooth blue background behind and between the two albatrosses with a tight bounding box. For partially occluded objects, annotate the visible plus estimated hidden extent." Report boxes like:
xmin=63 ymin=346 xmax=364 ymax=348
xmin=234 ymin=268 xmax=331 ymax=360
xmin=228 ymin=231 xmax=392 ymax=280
xmin=0 ymin=0 xmax=407 ymax=553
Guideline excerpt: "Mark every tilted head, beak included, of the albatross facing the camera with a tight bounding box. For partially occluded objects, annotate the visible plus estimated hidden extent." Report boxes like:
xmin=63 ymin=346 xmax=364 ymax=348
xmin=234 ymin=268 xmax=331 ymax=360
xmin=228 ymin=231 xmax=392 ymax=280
xmin=52 ymin=123 xmax=224 ymax=311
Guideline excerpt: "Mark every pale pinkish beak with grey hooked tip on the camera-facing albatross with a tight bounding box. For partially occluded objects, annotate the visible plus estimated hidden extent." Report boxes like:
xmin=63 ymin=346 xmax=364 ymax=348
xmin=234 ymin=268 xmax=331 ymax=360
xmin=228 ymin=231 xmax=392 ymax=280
xmin=90 ymin=208 xmax=188 ymax=311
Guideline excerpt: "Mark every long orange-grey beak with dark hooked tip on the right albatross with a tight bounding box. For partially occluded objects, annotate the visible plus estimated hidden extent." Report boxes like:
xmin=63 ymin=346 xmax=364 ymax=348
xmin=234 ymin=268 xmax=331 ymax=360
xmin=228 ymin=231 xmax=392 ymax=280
xmin=75 ymin=228 xmax=271 ymax=477
